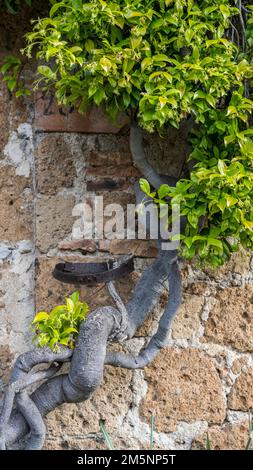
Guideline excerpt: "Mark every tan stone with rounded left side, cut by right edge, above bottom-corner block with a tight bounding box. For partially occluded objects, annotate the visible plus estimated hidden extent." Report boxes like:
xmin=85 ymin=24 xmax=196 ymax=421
xmin=228 ymin=367 xmax=253 ymax=411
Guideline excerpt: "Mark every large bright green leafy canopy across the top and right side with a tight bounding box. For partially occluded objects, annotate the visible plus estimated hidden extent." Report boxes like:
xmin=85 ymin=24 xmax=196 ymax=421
xmin=2 ymin=0 xmax=253 ymax=266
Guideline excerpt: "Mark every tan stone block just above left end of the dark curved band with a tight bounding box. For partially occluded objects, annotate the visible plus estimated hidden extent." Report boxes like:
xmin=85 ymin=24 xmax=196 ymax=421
xmin=36 ymin=195 xmax=75 ymax=253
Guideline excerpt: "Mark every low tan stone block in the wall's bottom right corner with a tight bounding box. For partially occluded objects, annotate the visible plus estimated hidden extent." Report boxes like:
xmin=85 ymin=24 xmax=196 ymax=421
xmin=192 ymin=422 xmax=249 ymax=450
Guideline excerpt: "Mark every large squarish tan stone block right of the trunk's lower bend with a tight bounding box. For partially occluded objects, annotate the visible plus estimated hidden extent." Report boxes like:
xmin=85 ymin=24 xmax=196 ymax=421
xmin=140 ymin=348 xmax=226 ymax=432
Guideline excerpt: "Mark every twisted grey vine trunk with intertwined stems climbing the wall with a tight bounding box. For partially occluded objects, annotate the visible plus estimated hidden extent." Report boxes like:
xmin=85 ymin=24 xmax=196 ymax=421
xmin=0 ymin=126 xmax=181 ymax=450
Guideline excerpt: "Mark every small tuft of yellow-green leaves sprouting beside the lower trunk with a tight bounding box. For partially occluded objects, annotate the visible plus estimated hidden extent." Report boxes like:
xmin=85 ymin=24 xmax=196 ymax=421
xmin=31 ymin=292 xmax=89 ymax=351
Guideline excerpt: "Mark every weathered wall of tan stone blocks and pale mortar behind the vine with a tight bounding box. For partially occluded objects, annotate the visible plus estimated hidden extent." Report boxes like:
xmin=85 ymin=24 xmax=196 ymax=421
xmin=0 ymin=4 xmax=253 ymax=449
